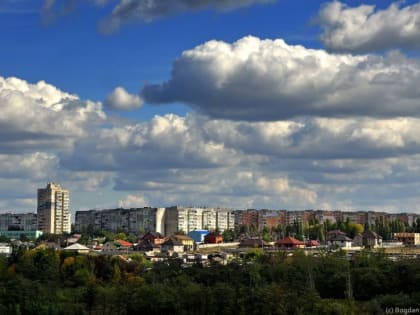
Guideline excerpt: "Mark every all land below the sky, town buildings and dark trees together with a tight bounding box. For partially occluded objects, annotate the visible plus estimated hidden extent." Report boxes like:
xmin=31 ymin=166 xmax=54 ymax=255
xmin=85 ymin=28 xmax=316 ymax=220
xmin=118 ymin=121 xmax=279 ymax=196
xmin=0 ymin=190 xmax=420 ymax=314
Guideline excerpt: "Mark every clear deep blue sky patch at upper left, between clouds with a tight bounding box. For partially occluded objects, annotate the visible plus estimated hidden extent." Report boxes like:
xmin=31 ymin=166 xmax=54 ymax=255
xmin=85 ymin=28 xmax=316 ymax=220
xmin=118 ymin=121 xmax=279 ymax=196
xmin=0 ymin=1 xmax=320 ymax=100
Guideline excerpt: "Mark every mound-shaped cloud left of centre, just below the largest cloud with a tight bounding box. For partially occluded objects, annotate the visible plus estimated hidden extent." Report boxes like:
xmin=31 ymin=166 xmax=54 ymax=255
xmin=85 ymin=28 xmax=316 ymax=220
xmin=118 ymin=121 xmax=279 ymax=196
xmin=63 ymin=114 xmax=241 ymax=170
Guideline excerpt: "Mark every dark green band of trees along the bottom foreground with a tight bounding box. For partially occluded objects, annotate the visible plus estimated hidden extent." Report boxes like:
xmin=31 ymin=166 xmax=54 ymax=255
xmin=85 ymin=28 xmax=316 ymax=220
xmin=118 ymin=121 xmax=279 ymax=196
xmin=0 ymin=249 xmax=420 ymax=315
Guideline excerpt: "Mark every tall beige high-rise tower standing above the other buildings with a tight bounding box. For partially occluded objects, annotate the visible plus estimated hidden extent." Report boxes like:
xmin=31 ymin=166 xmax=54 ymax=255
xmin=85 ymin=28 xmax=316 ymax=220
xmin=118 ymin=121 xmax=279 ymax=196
xmin=37 ymin=183 xmax=71 ymax=234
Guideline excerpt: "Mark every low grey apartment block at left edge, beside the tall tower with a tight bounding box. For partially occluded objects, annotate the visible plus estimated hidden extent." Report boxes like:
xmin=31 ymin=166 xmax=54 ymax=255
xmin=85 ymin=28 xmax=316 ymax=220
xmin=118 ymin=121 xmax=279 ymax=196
xmin=0 ymin=213 xmax=38 ymax=231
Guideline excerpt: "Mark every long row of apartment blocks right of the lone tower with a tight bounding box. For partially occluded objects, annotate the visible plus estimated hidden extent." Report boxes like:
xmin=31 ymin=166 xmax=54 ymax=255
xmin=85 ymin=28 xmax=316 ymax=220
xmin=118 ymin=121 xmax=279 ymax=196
xmin=75 ymin=206 xmax=420 ymax=235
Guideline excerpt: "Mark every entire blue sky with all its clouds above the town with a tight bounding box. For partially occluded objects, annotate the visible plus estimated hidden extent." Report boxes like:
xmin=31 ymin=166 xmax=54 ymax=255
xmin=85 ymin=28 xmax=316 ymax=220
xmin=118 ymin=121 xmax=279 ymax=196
xmin=0 ymin=0 xmax=420 ymax=213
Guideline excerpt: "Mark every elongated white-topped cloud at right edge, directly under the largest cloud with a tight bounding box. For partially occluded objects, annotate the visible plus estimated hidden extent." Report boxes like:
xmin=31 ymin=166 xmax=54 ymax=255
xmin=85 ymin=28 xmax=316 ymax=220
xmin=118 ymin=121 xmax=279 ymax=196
xmin=202 ymin=118 xmax=420 ymax=159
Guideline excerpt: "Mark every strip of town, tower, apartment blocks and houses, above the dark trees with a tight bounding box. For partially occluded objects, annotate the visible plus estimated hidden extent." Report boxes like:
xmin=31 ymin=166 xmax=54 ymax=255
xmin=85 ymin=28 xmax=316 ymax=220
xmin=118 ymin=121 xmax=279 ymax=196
xmin=0 ymin=183 xmax=420 ymax=253
